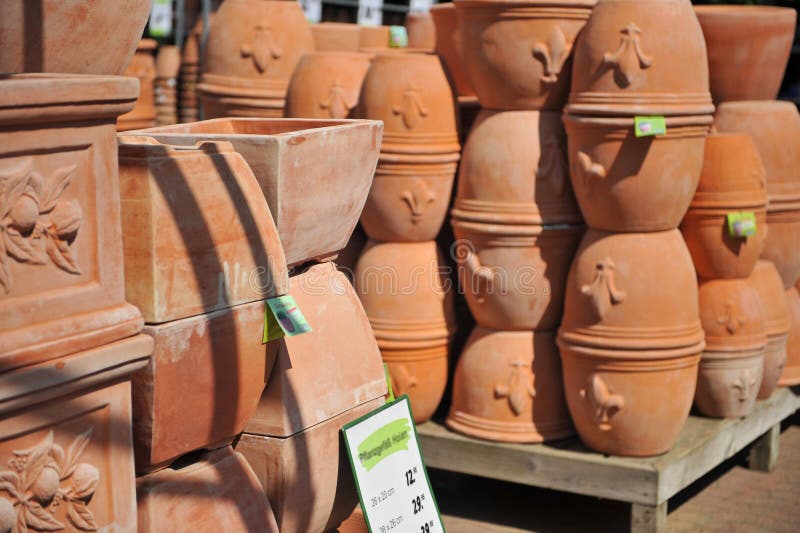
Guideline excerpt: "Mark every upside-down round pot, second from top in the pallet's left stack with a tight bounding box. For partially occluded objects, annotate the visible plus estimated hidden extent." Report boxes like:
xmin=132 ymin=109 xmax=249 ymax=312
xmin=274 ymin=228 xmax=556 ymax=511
xmin=453 ymin=110 xmax=583 ymax=224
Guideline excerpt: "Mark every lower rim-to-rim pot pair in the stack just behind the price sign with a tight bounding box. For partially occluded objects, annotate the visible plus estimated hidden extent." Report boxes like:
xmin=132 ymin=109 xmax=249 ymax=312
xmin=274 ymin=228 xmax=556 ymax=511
xmin=355 ymin=241 xmax=455 ymax=424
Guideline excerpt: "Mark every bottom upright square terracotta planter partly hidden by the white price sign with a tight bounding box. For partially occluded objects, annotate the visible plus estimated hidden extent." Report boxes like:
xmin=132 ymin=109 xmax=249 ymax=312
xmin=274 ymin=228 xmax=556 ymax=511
xmin=236 ymin=397 xmax=384 ymax=533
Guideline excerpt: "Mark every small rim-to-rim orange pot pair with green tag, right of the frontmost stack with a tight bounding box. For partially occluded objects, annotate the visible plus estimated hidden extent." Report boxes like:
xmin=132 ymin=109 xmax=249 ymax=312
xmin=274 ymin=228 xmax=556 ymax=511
xmin=681 ymin=134 xmax=767 ymax=279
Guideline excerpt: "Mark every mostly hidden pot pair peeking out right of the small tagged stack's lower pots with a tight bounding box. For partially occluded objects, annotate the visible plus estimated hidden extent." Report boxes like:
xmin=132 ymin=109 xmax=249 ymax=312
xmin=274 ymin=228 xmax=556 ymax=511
xmin=748 ymin=259 xmax=792 ymax=400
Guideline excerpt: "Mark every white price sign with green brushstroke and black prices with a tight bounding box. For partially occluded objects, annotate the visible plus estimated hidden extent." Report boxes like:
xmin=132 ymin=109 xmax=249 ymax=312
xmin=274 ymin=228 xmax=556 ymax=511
xmin=343 ymin=396 xmax=444 ymax=533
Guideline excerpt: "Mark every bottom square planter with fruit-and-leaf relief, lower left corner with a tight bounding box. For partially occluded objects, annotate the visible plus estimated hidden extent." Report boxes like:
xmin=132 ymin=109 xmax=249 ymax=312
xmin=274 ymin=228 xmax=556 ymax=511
xmin=0 ymin=335 xmax=152 ymax=533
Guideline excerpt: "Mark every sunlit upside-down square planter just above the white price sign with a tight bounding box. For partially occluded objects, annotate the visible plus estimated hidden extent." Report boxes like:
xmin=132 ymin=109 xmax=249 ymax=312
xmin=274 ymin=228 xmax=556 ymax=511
xmin=245 ymin=263 xmax=387 ymax=437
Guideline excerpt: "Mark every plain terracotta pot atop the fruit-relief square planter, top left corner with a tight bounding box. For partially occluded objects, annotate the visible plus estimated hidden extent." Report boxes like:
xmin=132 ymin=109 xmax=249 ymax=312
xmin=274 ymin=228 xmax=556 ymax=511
xmin=0 ymin=0 xmax=150 ymax=74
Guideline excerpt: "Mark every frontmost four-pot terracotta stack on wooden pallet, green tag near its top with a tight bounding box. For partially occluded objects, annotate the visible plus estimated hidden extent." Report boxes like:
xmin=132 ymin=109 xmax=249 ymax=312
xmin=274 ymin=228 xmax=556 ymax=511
xmin=559 ymin=0 xmax=714 ymax=456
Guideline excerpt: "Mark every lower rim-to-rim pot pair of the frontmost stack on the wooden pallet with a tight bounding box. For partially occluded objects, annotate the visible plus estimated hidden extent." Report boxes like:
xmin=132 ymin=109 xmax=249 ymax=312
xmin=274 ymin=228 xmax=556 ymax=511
xmin=558 ymin=230 xmax=705 ymax=456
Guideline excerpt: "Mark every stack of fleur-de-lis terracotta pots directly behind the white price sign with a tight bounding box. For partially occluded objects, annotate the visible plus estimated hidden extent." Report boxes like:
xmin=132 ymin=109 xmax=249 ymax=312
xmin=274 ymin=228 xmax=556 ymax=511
xmin=355 ymin=51 xmax=460 ymax=422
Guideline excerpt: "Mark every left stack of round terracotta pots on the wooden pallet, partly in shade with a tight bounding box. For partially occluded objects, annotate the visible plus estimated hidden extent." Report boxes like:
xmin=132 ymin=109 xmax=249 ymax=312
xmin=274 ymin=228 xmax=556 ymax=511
xmin=435 ymin=0 xmax=594 ymax=442
